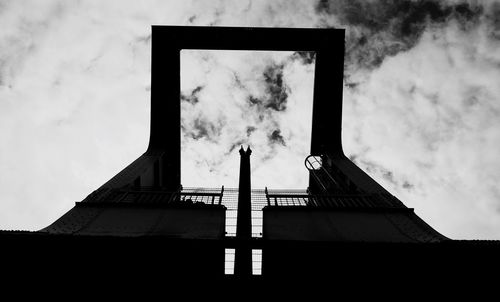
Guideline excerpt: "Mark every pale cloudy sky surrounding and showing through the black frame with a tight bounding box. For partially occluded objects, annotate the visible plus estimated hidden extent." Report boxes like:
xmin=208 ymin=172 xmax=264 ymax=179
xmin=0 ymin=0 xmax=500 ymax=239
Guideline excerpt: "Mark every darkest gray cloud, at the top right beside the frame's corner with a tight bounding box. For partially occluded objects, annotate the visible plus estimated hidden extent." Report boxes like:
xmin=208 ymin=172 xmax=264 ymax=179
xmin=316 ymin=0 xmax=485 ymax=71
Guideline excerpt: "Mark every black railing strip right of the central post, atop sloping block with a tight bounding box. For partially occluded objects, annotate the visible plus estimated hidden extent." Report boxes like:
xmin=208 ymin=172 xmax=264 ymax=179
xmin=265 ymin=187 xmax=404 ymax=208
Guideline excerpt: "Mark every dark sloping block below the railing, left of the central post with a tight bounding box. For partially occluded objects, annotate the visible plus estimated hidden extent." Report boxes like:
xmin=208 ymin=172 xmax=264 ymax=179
xmin=40 ymin=203 xmax=225 ymax=239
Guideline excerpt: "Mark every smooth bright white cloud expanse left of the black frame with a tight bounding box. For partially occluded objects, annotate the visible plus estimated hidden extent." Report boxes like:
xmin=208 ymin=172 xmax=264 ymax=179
xmin=0 ymin=1 xmax=201 ymax=230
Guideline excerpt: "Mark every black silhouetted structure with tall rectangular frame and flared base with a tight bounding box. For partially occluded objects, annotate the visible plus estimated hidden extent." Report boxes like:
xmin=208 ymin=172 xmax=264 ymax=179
xmin=0 ymin=26 xmax=500 ymax=284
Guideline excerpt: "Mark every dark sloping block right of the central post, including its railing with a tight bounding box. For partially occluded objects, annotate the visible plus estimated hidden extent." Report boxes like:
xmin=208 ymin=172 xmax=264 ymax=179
xmin=263 ymin=190 xmax=449 ymax=243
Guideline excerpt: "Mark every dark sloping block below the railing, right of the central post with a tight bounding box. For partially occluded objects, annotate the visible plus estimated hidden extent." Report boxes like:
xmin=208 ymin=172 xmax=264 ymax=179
xmin=263 ymin=207 xmax=448 ymax=243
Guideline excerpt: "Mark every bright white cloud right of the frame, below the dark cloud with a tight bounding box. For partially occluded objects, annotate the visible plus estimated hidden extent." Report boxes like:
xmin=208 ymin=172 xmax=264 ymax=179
xmin=343 ymin=24 xmax=500 ymax=238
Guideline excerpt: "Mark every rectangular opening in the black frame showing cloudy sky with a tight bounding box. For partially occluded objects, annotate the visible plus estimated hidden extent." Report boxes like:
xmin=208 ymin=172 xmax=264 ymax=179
xmin=180 ymin=50 xmax=315 ymax=188
